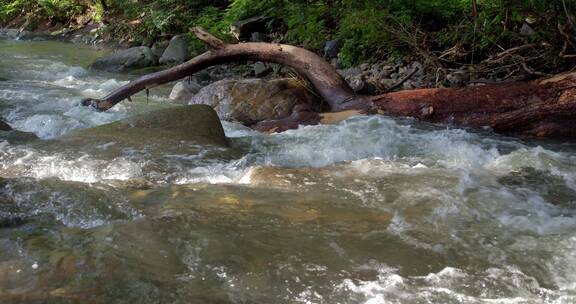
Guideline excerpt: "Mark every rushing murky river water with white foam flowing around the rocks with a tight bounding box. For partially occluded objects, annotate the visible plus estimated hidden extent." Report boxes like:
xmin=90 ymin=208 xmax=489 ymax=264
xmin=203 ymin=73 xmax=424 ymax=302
xmin=0 ymin=36 xmax=576 ymax=304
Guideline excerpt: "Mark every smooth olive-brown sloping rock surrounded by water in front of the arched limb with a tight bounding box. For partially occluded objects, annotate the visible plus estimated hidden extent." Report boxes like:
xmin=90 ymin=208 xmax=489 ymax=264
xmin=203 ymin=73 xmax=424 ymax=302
xmin=58 ymin=105 xmax=228 ymax=147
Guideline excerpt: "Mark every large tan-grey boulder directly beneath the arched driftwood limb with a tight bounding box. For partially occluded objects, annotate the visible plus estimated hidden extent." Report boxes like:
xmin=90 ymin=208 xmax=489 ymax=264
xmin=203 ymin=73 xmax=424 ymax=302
xmin=190 ymin=78 xmax=320 ymax=124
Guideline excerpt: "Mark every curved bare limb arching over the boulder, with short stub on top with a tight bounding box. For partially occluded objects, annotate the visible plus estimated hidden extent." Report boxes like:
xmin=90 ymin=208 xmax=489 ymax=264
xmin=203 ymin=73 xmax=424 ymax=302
xmin=83 ymin=28 xmax=368 ymax=111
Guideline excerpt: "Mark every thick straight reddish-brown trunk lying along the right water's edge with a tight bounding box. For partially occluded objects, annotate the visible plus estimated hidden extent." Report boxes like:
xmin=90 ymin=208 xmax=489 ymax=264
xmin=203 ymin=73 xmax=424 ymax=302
xmin=372 ymin=73 xmax=576 ymax=137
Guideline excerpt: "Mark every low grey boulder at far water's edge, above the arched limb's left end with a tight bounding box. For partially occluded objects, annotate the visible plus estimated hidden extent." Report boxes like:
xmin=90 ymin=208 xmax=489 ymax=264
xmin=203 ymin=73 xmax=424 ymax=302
xmin=90 ymin=46 xmax=156 ymax=73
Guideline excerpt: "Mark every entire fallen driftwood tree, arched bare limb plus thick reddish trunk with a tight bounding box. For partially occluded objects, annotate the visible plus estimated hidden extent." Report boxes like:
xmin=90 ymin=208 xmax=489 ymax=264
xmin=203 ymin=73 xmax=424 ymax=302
xmin=83 ymin=28 xmax=576 ymax=138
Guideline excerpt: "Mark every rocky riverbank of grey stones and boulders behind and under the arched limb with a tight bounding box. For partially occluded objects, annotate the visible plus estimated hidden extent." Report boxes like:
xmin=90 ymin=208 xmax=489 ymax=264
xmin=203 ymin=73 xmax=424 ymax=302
xmin=0 ymin=23 xmax=482 ymax=128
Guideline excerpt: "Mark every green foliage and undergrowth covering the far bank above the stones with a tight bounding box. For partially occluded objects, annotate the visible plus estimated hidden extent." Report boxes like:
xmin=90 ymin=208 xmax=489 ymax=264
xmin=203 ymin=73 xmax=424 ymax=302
xmin=0 ymin=0 xmax=576 ymax=65
